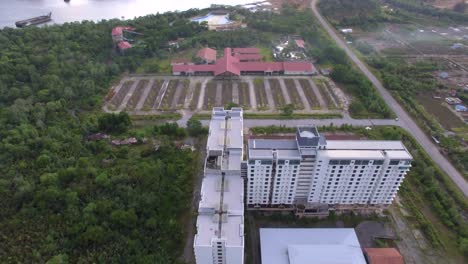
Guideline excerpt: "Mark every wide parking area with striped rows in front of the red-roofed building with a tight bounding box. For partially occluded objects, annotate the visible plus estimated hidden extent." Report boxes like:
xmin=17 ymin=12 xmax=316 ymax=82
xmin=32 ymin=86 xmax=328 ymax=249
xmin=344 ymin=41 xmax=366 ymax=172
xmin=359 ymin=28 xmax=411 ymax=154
xmin=104 ymin=76 xmax=348 ymax=114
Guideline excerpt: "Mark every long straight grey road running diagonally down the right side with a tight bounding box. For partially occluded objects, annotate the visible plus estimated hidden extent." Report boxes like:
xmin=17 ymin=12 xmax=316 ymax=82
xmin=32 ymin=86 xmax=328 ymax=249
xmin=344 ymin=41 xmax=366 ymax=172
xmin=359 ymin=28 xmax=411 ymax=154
xmin=311 ymin=0 xmax=468 ymax=197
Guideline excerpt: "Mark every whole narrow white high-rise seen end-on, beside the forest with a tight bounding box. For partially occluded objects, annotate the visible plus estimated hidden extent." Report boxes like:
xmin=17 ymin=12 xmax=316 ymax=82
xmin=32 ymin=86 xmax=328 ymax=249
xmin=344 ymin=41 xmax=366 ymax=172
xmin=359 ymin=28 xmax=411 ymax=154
xmin=194 ymin=108 xmax=244 ymax=264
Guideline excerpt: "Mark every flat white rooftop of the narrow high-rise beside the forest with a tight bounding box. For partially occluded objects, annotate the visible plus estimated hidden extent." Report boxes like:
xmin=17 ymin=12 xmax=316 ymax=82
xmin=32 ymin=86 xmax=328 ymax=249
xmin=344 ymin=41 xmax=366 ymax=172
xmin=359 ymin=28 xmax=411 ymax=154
xmin=194 ymin=108 xmax=244 ymax=247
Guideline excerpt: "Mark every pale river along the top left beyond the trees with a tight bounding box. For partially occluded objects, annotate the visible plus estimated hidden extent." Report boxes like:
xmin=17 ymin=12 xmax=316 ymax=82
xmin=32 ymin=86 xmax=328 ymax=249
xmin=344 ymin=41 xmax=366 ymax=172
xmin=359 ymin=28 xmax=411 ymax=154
xmin=0 ymin=0 xmax=258 ymax=28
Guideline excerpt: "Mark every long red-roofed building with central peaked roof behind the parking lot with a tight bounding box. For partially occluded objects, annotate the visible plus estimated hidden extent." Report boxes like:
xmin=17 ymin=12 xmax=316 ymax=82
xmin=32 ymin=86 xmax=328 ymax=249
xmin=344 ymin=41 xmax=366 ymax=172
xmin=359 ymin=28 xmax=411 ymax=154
xmin=172 ymin=48 xmax=317 ymax=78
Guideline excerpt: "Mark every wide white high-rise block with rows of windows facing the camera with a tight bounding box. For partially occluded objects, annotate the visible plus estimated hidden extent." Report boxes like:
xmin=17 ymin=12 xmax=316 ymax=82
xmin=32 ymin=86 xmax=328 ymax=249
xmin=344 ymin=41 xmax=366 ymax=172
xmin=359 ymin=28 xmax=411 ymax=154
xmin=246 ymin=127 xmax=412 ymax=208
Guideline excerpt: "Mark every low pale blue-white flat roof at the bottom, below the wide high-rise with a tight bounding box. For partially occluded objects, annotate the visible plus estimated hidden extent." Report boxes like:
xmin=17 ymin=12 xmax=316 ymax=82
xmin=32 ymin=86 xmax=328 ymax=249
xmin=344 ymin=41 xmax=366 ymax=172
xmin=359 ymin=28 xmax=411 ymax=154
xmin=260 ymin=228 xmax=366 ymax=264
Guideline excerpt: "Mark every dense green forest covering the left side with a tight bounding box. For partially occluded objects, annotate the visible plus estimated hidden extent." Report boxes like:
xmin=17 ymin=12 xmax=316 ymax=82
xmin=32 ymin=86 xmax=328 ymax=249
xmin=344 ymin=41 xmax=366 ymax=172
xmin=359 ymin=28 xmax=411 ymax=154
xmin=0 ymin=9 xmax=206 ymax=263
